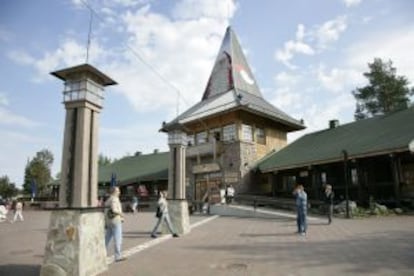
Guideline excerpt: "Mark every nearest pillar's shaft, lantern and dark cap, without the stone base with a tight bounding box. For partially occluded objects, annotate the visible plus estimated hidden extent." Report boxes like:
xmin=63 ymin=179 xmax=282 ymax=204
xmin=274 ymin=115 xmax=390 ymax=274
xmin=52 ymin=64 xmax=116 ymax=207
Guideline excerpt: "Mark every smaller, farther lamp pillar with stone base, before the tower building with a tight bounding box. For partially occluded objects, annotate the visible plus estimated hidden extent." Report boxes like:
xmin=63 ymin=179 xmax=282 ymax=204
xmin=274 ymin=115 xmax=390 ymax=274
xmin=168 ymin=129 xmax=190 ymax=234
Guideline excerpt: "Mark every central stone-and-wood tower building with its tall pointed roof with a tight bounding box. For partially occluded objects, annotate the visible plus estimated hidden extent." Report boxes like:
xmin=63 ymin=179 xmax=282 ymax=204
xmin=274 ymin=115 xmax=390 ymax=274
xmin=161 ymin=27 xmax=304 ymax=201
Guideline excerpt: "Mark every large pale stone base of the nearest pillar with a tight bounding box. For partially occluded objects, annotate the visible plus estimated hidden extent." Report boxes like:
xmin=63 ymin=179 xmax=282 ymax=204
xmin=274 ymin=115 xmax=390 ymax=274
xmin=40 ymin=209 xmax=108 ymax=276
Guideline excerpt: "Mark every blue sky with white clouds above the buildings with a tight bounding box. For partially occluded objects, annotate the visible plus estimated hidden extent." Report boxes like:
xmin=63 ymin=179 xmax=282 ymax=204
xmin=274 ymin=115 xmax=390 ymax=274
xmin=0 ymin=0 xmax=414 ymax=187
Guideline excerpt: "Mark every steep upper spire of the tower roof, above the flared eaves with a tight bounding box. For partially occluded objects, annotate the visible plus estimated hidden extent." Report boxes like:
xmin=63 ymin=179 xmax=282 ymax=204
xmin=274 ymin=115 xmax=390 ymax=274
xmin=202 ymin=27 xmax=262 ymax=100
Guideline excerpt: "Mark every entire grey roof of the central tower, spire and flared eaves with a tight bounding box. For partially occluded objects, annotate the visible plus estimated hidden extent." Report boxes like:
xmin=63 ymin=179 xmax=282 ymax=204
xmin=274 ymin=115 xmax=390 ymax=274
xmin=161 ymin=27 xmax=305 ymax=132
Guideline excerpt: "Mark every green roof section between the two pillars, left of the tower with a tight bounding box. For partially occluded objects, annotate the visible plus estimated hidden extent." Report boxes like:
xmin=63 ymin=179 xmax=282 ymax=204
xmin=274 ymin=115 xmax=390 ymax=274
xmin=98 ymin=152 xmax=170 ymax=185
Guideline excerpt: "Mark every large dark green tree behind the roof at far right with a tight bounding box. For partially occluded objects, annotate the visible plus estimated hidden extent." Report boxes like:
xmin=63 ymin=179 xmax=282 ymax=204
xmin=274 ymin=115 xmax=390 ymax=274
xmin=352 ymin=58 xmax=414 ymax=120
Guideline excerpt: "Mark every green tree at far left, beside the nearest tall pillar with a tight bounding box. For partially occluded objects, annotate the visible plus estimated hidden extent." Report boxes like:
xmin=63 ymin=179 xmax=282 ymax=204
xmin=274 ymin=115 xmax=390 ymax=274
xmin=23 ymin=149 xmax=54 ymax=195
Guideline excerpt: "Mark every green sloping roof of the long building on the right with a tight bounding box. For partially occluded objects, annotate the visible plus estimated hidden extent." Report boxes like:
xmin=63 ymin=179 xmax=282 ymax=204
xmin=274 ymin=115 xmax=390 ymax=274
xmin=257 ymin=107 xmax=414 ymax=172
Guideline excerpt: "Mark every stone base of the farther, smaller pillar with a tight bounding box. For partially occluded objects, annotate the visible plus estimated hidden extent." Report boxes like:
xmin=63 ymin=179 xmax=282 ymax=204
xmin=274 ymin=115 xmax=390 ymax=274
xmin=161 ymin=200 xmax=190 ymax=235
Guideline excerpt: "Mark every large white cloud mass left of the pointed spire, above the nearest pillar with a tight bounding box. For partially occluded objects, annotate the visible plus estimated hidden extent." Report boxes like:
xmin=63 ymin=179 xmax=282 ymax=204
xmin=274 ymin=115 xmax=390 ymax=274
xmin=10 ymin=0 xmax=236 ymax=116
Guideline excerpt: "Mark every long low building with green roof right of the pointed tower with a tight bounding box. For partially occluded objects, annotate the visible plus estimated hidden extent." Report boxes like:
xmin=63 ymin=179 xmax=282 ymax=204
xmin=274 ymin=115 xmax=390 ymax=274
xmin=256 ymin=107 xmax=414 ymax=207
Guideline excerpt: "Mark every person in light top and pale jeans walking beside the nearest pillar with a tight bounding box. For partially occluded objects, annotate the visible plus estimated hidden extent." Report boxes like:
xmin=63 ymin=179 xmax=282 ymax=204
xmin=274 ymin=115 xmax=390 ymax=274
xmin=105 ymin=187 xmax=126 ymax=262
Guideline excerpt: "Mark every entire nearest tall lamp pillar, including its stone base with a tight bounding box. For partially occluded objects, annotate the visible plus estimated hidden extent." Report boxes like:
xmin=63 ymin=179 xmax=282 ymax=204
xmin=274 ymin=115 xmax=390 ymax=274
xmin=40 ymin=64 xmax=116 ymax=276
